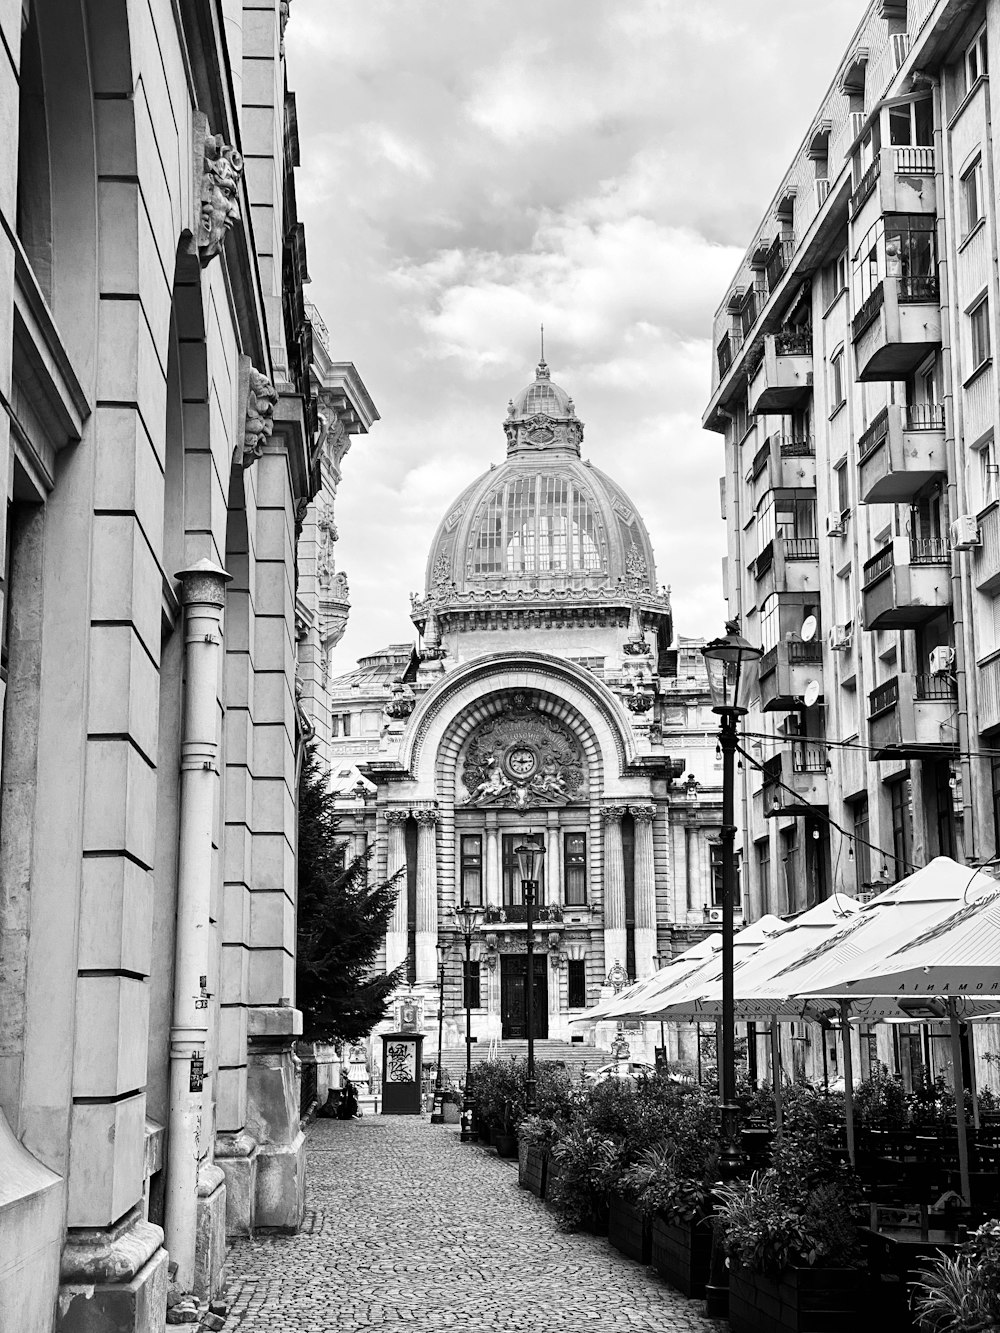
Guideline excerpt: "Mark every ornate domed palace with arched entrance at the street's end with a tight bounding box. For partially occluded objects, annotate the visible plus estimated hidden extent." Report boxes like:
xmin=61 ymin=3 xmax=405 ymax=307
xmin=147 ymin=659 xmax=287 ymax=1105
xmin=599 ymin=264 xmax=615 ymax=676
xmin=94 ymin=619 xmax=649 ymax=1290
xmin=331 ymin=360 xmax=721 ymax=1054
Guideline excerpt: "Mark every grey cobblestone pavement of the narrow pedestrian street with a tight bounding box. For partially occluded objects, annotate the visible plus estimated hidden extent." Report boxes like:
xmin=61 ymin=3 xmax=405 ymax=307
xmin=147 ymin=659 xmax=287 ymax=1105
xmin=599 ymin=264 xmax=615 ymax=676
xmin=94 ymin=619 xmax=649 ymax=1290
xmin=225 ymin=1116 xmax=727 ymax=1333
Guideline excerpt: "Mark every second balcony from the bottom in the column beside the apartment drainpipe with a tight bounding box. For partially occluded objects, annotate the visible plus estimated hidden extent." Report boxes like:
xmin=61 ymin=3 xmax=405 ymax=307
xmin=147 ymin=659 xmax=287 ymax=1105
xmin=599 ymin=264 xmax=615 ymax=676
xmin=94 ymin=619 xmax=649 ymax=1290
xmin=861 ymin=537 xmax=952 ymax=629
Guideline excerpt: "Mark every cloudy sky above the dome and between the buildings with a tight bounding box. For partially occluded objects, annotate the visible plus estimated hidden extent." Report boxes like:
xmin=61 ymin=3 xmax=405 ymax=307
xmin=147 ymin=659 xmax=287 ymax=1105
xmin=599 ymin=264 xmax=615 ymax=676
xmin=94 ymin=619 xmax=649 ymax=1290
xmin=285 ymin=0 xmax=865 ymax=674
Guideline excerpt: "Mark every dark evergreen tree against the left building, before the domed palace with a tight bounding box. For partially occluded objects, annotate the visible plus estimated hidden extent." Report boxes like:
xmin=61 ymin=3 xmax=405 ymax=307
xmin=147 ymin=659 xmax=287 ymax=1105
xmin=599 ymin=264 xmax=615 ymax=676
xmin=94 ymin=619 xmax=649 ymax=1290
xmin=296 ymin=746 xmax=403 ymax=1042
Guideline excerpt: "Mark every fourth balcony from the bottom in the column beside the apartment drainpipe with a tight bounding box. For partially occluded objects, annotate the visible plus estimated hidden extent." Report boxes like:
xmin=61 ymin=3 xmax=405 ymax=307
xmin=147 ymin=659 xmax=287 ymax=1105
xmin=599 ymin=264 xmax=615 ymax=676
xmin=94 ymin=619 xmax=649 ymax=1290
xmin=851 ymin=276 xmax=941 ymax=380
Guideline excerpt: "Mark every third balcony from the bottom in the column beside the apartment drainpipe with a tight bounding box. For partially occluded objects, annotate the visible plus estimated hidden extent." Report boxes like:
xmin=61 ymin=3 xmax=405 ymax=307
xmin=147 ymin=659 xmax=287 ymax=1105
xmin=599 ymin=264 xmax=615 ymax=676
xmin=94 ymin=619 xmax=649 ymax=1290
xmin=857 ymin=403 xmax=948 ymax=504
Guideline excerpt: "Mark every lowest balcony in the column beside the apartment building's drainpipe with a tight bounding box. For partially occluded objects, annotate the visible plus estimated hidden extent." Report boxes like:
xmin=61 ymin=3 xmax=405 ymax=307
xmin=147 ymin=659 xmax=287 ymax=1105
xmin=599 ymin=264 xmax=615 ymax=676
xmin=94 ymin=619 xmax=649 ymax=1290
xmin=868 ymin=672 xmax=959 ymax=758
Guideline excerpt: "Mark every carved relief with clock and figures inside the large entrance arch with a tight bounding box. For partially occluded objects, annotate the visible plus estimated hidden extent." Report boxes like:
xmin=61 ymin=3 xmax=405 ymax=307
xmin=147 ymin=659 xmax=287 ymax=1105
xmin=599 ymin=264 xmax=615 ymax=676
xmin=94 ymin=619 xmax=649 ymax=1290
xmin=461 ymin=693 xmax=584 ymax=810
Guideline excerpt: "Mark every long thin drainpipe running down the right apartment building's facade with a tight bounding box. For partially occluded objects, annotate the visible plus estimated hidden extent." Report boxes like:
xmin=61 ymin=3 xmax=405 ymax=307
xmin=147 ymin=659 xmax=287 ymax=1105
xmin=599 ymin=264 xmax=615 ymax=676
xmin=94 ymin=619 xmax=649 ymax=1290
xmin=932 ymin=80 xmax=979 ymax=861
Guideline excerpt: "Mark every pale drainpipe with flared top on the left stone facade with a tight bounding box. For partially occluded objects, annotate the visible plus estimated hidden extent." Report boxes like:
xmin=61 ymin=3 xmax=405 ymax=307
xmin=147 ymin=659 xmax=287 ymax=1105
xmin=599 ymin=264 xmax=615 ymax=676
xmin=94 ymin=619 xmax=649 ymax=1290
xmin=164 ymin=560 xmax=231 ymax=1292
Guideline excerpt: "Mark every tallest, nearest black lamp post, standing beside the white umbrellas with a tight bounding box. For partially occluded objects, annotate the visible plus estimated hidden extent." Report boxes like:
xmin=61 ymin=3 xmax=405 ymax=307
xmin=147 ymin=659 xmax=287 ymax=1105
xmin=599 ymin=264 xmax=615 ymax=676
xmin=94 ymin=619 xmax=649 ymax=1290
xmin=703 ymin=620 xmax=763 ymax=1180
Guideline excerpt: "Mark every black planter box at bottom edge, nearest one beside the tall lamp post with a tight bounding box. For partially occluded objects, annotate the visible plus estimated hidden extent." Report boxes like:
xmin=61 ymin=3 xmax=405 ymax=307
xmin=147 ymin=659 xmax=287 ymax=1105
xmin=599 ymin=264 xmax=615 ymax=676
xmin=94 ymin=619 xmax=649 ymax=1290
xmin=729 ymin=1262 xmax=863 ymax=1333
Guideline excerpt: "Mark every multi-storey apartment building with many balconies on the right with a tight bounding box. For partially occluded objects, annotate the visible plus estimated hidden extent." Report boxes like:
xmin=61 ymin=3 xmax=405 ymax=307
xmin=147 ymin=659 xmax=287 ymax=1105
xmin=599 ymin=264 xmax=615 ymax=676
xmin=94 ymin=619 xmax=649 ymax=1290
xmin=704 ymin=0 xmax=1000 ymax=949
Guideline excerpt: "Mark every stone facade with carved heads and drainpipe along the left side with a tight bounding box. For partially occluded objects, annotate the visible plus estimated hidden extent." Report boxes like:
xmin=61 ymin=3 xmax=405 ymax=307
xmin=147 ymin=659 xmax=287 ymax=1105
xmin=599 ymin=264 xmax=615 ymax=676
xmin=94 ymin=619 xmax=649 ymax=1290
xmin=0 ymin=0 xmax=337 ymax=1333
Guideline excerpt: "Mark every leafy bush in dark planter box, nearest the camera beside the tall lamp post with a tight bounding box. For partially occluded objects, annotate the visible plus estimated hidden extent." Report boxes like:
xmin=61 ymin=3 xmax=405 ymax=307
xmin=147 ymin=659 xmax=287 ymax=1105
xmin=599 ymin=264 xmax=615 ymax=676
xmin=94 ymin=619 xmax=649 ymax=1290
xmin=713 ymin=1093 xmax=861 ymax=1333
